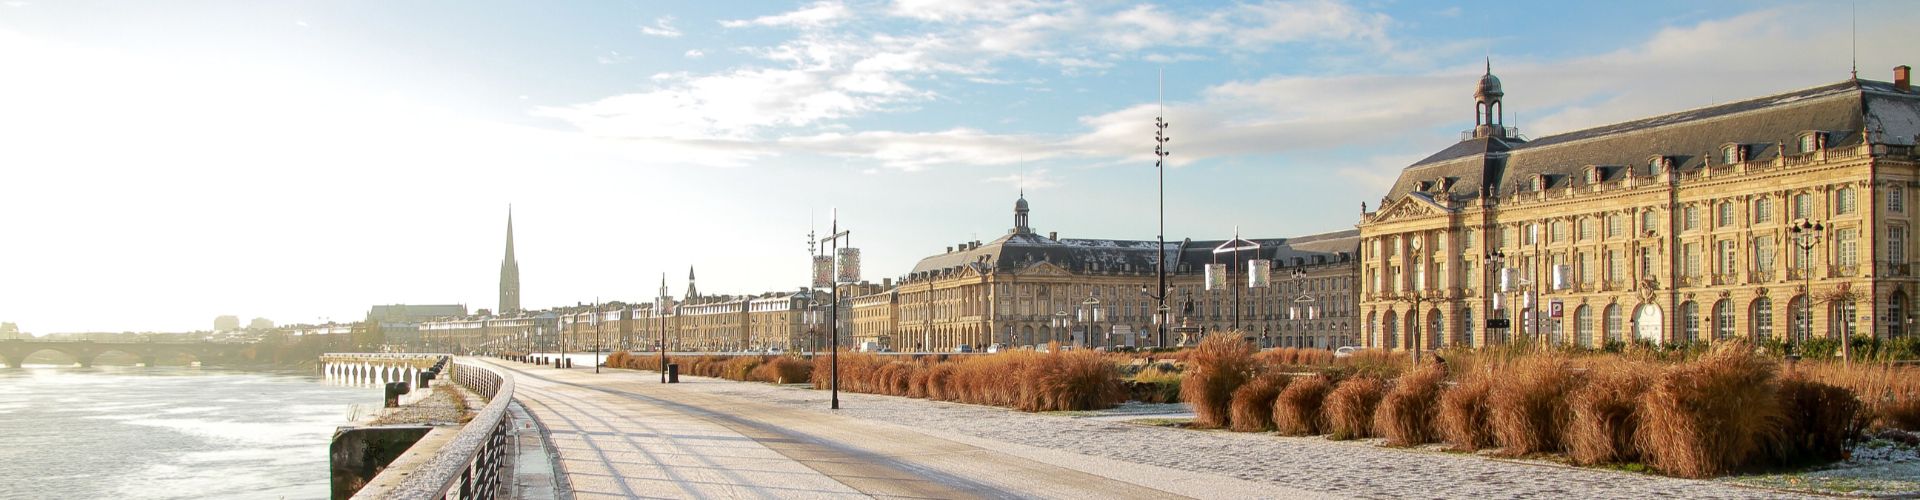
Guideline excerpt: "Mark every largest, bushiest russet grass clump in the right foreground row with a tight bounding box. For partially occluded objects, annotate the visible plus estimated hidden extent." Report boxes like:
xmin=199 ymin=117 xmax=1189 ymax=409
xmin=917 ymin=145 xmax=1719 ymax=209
xmin=1634 ymin=342 xmax=1786 ymax=479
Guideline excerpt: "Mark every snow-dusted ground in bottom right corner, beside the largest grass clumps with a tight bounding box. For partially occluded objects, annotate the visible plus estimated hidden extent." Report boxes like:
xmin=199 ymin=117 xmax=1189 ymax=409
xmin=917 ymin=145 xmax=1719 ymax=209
xmin=1722 ymin=431 xmax=1920 ymax=496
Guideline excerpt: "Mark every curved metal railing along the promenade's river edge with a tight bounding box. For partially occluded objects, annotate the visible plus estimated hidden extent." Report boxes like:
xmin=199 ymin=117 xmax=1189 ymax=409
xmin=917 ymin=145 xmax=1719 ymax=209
xmin=376 ymin=362 xmax=513 ymax=498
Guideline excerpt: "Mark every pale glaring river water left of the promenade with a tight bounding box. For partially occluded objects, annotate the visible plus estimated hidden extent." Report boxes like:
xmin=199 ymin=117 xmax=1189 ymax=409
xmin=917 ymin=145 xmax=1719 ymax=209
xmin=0 ymin=363 xmax=380 ymax=498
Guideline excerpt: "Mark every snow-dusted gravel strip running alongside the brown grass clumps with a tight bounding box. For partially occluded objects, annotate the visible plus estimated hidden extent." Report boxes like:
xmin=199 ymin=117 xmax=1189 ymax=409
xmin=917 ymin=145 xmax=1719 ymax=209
xmin=652 ymin=377 xmax=1799 ymax=498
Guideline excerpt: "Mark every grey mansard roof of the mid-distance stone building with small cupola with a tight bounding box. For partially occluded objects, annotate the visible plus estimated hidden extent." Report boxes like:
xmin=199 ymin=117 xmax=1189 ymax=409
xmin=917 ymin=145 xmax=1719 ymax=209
xmin=906 ymin=229 xmax=1359 ymax=281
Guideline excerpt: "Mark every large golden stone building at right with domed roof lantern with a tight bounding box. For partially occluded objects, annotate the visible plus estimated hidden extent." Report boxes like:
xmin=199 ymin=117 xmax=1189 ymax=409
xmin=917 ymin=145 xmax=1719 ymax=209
xmin=1359 ymin=65 xmax=1920 ymax=348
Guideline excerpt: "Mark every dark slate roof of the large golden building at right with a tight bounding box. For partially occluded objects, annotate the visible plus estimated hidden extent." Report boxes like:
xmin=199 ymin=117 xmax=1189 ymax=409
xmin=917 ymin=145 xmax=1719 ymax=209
xmin=1386 ymin=81 xmax=1920 ymax=200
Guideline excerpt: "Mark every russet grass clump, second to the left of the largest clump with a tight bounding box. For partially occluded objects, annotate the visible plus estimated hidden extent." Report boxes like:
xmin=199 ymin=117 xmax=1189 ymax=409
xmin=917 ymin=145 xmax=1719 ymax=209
xmin=1486 ymin=354 xmax=1580 ymax=456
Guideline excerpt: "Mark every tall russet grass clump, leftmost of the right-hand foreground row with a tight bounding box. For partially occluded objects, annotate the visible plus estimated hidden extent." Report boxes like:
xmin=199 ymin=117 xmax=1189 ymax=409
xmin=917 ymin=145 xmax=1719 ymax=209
xmin=1181 ymin=331 xmax=1256 ymax=429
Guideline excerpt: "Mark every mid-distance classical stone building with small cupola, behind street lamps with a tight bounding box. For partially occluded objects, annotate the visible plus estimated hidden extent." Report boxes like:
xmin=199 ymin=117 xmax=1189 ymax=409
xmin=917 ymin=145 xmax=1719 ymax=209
xmin=893 ymin=196 xmax=1357 ymax=350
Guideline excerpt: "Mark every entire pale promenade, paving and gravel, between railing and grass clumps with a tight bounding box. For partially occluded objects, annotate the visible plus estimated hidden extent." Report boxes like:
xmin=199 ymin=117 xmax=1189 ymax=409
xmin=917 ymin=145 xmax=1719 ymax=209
xmin=497 ymin=362 xmax=1791 ymax=498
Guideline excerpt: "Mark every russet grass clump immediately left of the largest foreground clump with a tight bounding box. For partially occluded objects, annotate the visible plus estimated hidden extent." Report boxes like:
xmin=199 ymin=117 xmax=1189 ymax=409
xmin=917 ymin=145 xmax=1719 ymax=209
xmin=1565 ymin=358 xmax=1659 ymax=465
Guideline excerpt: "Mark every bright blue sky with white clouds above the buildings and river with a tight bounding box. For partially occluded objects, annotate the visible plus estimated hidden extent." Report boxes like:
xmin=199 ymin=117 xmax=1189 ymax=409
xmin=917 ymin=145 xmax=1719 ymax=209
xmin=0 ymin=0 xmax=1920 ymax=335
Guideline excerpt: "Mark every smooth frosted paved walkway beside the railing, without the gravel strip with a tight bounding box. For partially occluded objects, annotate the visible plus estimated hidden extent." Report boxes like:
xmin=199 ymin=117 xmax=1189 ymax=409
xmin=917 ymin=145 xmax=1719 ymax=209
xmin=495 ymin=362 xmax=1327 ymax=498
